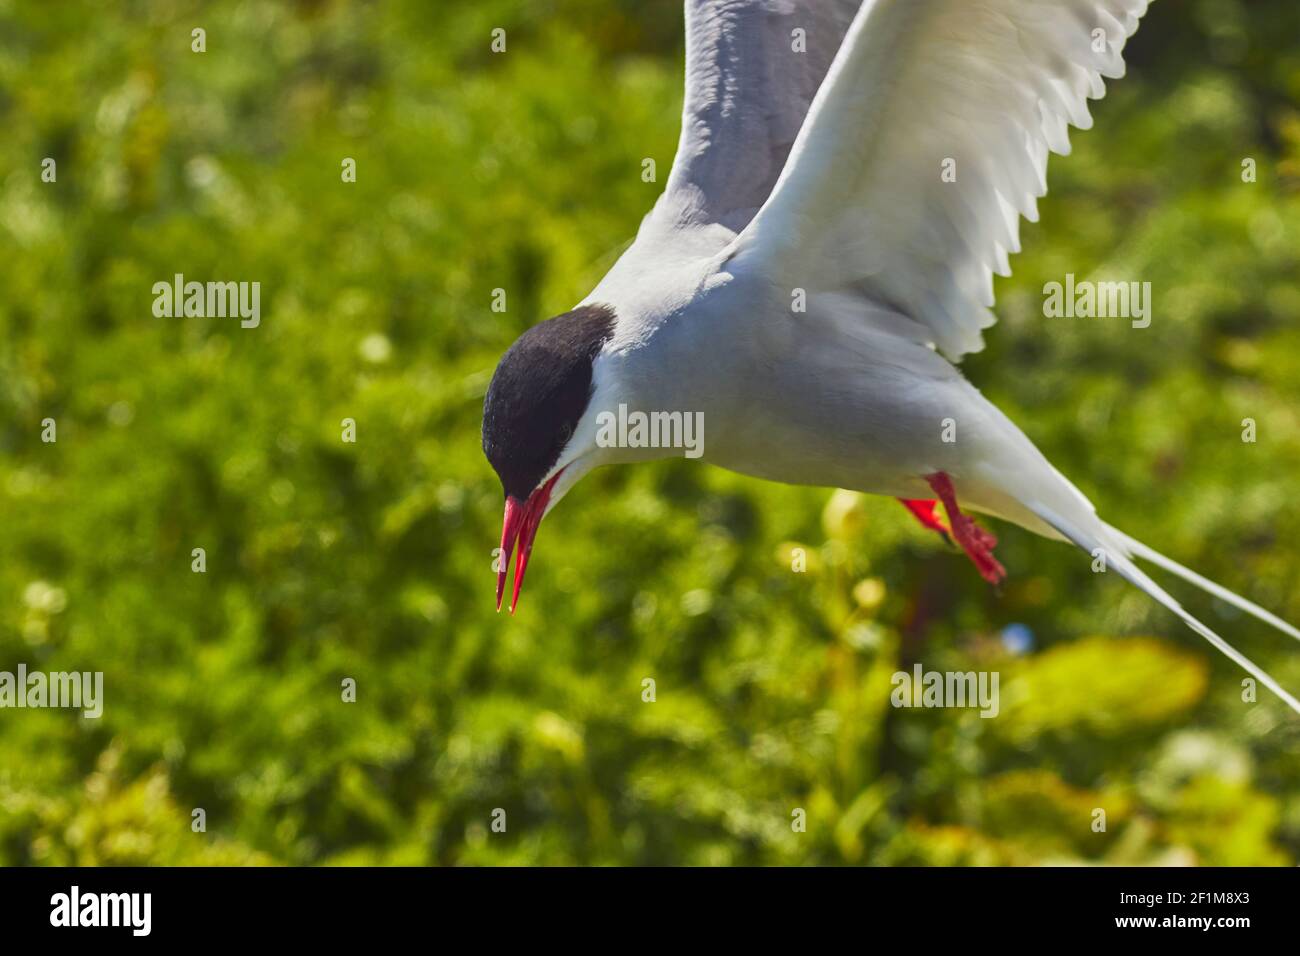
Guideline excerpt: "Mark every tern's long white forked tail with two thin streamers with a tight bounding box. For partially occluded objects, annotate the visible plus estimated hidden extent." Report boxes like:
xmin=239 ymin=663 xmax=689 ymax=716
xmin=1030 ymin=505 xmax=1300 ymax=714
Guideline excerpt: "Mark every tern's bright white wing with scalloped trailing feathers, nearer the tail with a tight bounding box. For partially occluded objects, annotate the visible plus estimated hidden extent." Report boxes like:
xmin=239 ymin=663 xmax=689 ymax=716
xmin=736 ymin=0 xmax=1148 ymax=359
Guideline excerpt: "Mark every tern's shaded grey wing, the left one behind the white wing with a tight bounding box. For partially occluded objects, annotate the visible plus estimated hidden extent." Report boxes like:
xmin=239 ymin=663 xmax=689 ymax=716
xmin=654 ymin=0 xmax=861 ymax=232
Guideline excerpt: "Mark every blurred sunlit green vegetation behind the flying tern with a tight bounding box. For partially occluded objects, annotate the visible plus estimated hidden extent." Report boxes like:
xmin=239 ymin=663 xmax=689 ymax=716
xmin=0 ymin=0 xmax=1300 ymax=865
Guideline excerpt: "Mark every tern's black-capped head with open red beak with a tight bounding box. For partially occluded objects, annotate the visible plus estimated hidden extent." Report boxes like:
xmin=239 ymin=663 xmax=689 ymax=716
xmin=484 ymin=306 xmax=615 ymax=614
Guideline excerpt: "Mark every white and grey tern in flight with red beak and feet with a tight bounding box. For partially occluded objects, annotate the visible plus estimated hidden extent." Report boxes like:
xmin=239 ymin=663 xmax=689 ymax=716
xmin=482 ymin=0 xmax=1300 ymax=713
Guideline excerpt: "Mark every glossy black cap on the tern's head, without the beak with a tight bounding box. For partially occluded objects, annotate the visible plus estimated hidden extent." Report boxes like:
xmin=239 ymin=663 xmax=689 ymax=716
xmin=484 ymin=304 xmax=615 ymax=501
